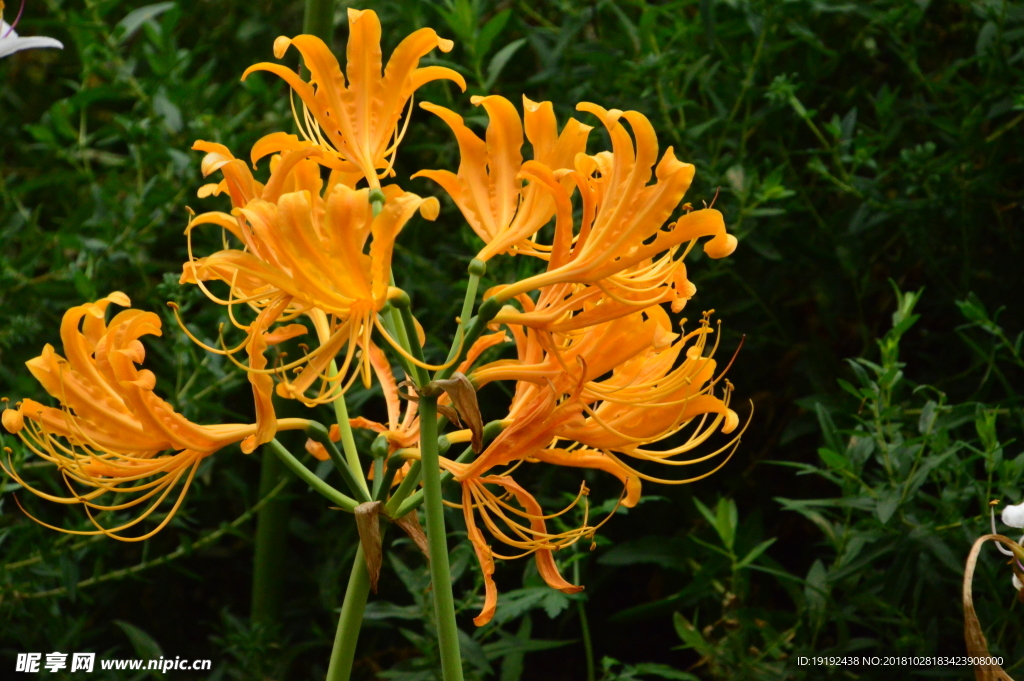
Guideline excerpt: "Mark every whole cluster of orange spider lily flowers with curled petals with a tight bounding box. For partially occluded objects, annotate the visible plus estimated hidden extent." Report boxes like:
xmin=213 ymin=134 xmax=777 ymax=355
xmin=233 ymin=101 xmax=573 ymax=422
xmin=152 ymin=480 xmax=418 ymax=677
xmin=3 ymin=9 xmax=741 ymax=625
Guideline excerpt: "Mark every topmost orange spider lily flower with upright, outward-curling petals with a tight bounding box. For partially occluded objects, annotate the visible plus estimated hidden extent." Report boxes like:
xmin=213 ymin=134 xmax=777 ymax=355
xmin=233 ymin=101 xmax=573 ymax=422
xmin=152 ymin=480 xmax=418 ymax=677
xmin=242 ymin=8 xmax=466 ymax=188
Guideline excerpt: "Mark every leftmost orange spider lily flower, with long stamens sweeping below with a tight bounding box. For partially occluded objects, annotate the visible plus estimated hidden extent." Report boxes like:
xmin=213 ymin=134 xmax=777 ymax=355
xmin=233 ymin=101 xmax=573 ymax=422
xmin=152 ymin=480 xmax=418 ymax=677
xmin=0 ymin=292 xmax=307 ymax=542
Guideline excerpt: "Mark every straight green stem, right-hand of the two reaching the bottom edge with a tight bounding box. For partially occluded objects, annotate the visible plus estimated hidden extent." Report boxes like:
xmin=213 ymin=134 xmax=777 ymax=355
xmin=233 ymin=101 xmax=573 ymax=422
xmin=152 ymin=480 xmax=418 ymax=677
xmin=420 ymin=396 xmax=463 ymax=681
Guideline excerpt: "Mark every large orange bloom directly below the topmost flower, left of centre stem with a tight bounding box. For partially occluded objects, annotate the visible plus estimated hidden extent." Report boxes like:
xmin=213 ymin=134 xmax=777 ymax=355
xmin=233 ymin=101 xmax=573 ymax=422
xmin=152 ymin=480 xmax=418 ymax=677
xmin=181 ymin=141 xmax=438 ymax=439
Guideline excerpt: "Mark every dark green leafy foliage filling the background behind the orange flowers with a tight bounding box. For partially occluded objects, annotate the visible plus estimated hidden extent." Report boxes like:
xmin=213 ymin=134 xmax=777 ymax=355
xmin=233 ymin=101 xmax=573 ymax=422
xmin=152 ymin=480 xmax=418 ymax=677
xmin=0 ymin=0 xmax=1024 ymax=681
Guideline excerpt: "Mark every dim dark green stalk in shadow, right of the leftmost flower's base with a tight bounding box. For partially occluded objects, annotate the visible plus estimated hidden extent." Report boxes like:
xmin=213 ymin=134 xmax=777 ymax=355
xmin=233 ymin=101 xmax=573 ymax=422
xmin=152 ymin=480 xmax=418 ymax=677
xmin=250 ymin=450 xmax=291 ymax=624
